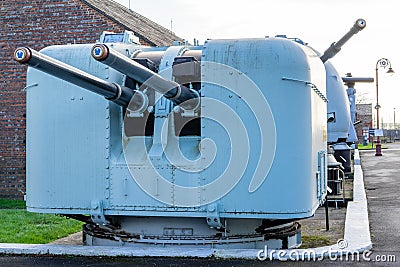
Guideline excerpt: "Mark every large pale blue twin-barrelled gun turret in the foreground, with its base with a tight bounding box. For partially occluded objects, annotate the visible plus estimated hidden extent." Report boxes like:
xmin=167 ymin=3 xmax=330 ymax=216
xmin=14 ymin=19 xmax=366 ymax=249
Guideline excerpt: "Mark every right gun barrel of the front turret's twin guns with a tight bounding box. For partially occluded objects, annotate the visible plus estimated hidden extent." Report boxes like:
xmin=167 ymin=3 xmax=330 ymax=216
xmin=92 ymin=44 xmax=200 ymax=109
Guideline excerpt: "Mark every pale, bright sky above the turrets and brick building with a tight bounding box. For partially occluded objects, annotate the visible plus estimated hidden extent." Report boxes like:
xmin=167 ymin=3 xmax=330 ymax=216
xmin=117 ymin=0 xmax=400 ymax=125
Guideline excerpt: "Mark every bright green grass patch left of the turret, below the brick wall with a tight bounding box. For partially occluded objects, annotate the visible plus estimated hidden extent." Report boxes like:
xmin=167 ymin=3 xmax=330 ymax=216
xmin=0 ymin=199 xmax=83 ymax=244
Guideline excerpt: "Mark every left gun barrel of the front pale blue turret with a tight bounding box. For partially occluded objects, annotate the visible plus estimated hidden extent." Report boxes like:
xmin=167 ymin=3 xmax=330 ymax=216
xmin=14 ymin=47 xmax=146 ymax=110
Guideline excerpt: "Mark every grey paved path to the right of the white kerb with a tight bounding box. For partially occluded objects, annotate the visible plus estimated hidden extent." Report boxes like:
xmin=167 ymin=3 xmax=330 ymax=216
xmin=360 ymin=143 xmax=400 ymax=266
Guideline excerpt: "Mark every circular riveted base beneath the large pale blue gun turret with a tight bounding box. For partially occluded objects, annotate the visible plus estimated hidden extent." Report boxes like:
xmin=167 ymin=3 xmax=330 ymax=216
xmin=83 ymin=217 xmax=301 ymax=249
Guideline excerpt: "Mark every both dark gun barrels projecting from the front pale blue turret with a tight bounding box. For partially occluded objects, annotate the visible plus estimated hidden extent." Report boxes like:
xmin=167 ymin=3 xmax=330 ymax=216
xmin=14 ymin=44 xmax=200 ymax=112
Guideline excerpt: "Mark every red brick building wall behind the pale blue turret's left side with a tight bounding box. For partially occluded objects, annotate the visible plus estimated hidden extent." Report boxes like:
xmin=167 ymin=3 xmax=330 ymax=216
xmin=0 ymin=0 xmax=148 ymax=199
